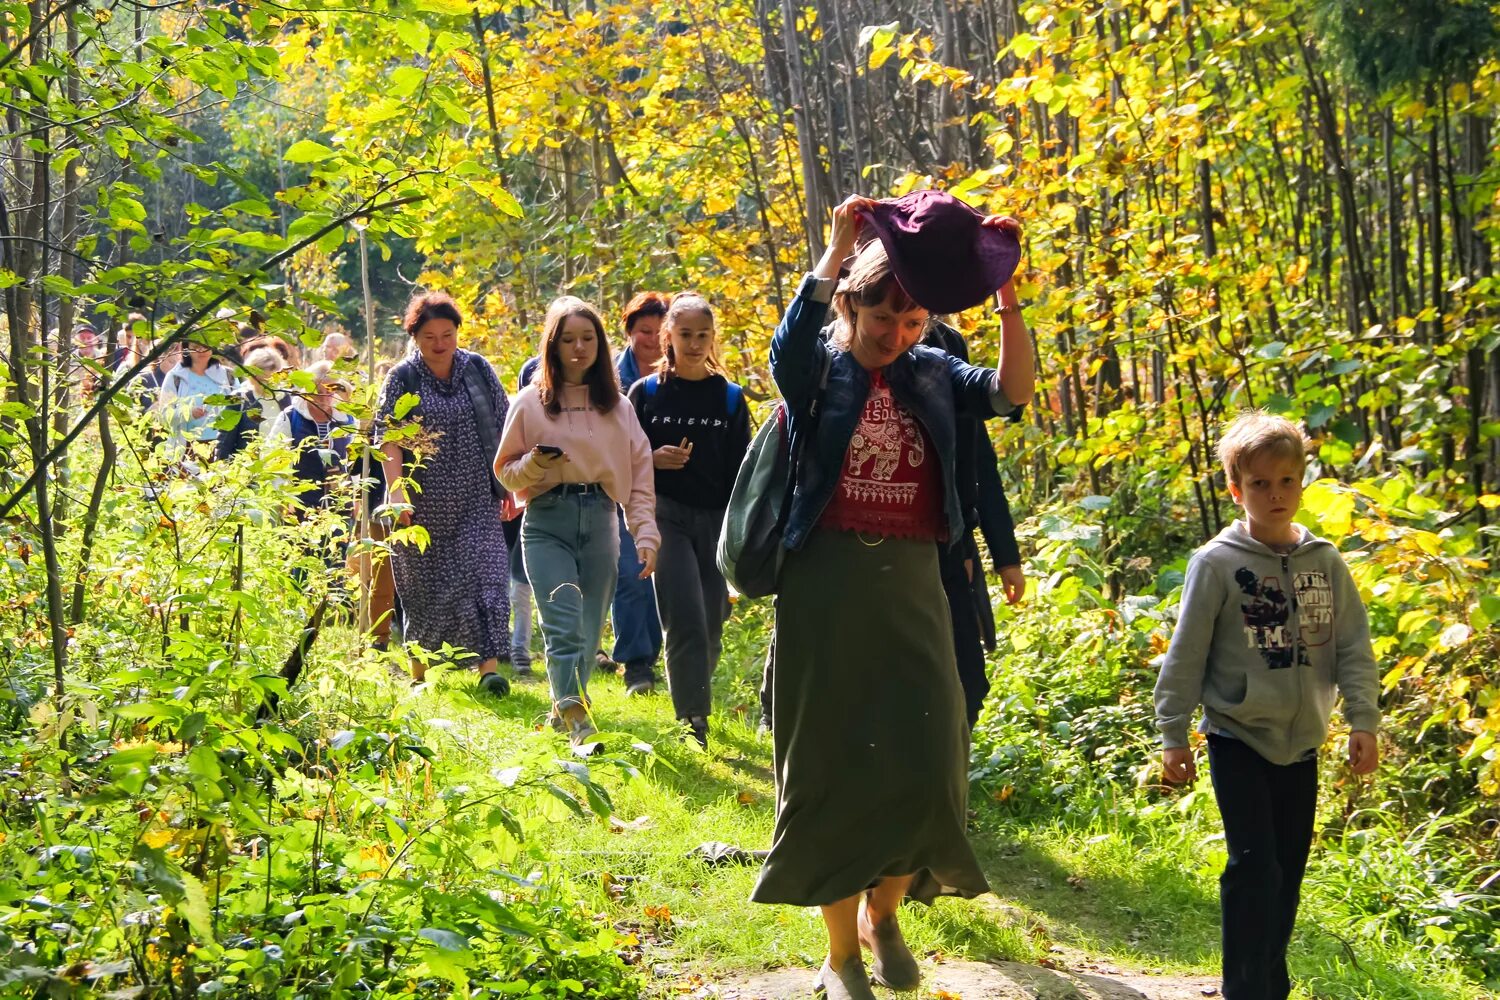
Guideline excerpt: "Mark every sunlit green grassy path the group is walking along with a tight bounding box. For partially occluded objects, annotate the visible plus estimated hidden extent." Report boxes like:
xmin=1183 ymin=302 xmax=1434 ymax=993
xmin=378 ymin=609 xmax=1488 ymax=1000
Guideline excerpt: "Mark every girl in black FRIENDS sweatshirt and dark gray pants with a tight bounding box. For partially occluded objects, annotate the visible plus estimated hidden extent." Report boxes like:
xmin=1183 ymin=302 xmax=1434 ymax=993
xmin=630 ymin=292 xmax=750 ymax=750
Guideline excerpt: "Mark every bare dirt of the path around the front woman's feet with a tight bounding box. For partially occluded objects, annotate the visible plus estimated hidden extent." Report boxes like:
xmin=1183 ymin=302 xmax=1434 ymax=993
xmin=660 ymin=955 xmax=1218 ymax=1000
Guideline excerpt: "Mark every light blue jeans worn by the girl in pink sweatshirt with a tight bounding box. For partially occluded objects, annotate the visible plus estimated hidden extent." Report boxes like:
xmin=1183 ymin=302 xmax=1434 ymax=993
xmin=521 ymin=487 xmax=620 ymax=709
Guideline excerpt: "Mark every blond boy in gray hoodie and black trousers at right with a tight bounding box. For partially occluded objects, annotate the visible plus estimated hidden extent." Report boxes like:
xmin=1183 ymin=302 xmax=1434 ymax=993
xmin=1155 ymin=411 xmax=1380 ymax=1000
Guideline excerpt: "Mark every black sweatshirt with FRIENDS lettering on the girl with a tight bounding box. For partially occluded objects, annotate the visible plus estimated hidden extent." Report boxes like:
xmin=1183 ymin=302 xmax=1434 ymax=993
xmin=629 ymin=375 xmax=750 ymax=510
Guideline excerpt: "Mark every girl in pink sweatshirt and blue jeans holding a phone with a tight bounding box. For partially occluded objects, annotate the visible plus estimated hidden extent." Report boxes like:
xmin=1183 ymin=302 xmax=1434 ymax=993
xmin=495 ymin=295 xmax=660 ymax=745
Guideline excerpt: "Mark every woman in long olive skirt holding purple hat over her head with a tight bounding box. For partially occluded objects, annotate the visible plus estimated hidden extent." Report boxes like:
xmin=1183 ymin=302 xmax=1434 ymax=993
xmin=752 ymin=192 xmax=1035 ymax=1000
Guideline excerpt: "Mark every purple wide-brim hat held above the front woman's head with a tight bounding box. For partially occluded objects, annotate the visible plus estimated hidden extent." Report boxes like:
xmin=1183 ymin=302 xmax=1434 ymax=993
xmin=860 ymin=190 xmax=1022 ymax=312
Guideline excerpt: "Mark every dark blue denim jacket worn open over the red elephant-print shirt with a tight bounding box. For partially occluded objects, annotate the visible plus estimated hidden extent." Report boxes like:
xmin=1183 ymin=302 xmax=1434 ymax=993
xmin=771 ymin=274 xmax=1019 ymax=550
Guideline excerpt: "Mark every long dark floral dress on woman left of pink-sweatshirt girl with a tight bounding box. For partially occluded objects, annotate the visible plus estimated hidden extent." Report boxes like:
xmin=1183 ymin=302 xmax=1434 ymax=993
xmin=380 ymin=351 xmax=510 ymax=664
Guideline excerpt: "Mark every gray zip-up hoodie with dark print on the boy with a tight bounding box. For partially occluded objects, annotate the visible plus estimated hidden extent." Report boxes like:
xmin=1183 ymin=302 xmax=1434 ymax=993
xmin=1157 ymin=520 xmax=1380 ymax=765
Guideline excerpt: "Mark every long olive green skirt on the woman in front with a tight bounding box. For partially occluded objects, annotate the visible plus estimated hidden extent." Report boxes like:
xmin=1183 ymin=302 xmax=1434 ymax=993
xmin=750 ymin=529 xmax=990 ymax=906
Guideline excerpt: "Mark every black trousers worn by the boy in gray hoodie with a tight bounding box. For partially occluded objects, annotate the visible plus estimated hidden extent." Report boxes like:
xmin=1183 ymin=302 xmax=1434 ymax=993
xmin=1209 ymin=736 xmax=1317 ymax=1000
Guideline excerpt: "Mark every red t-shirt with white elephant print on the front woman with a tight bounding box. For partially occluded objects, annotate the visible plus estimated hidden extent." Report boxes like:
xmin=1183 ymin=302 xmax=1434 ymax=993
xmin=818 ymin=372 xmax=947 ymax=541
